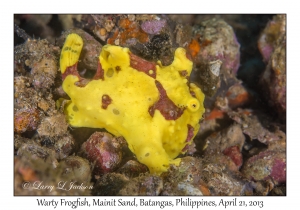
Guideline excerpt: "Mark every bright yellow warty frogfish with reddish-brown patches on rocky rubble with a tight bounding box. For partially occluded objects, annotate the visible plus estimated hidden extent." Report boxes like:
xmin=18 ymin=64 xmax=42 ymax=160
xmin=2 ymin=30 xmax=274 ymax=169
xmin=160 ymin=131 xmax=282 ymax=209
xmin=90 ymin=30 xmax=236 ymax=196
xmin=60 ymin=33 xmax=204 ymax=174
